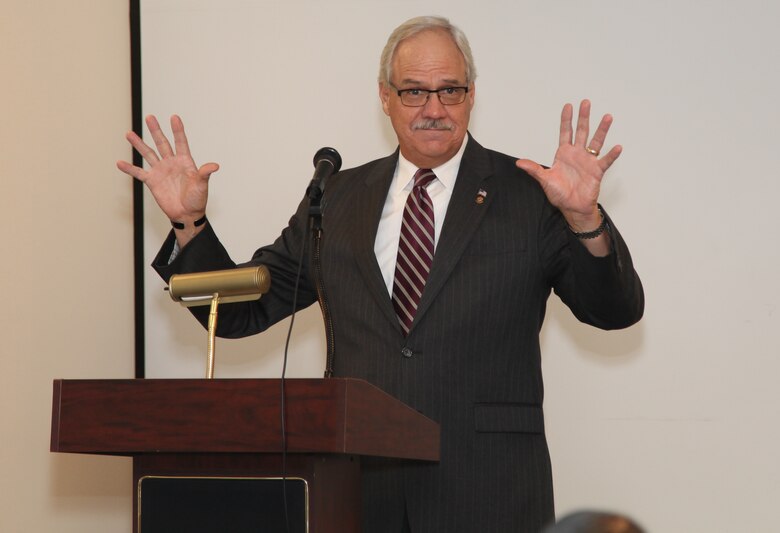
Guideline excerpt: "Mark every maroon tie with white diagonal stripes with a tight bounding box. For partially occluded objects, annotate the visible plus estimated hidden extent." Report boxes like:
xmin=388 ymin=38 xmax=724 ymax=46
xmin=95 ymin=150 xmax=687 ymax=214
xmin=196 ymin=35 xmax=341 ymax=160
xmin=393 ymin=168 xmax=436 ymax=335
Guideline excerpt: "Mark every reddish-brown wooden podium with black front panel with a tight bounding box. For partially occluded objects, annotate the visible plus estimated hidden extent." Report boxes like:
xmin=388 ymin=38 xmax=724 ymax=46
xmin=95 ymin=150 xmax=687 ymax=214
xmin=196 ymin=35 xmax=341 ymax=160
xmin=51 ymin=378 xmax=439 ymax=533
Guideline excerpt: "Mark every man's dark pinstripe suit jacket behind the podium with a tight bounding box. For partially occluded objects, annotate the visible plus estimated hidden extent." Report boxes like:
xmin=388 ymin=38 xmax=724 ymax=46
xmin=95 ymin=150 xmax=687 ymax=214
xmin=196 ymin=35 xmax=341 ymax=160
xmin=155 ymin=134 xmax=644 ymax=533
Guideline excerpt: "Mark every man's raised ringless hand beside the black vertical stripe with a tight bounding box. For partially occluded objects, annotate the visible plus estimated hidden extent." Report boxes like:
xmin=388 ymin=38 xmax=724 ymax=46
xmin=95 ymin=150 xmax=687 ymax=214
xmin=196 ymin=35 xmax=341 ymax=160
xmin=116 ymin=115 xmax=219 ymax=242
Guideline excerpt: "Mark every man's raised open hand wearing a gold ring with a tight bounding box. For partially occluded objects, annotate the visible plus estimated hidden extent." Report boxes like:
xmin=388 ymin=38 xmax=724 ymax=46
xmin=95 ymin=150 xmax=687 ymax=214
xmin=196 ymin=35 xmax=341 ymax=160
xmin=516 ymin=100 xmax=622 ymax=232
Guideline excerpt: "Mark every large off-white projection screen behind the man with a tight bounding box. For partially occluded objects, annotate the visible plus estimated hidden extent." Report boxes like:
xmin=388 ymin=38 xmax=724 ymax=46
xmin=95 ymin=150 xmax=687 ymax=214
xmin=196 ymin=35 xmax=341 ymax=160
xmin=141 ymin=0 xmax=780 ymax=532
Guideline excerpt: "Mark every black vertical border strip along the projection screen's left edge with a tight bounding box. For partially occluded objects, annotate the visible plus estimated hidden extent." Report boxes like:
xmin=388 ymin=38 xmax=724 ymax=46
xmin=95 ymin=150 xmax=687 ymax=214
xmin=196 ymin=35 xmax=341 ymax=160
xmin=130 ymin=0 xmax=146 ymax=378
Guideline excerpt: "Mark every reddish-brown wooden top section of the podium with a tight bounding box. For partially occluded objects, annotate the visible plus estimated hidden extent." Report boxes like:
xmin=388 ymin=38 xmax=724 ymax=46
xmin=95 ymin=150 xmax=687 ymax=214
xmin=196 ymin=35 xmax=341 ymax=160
xmin=51 ymin=378 xmax=439 ymax=461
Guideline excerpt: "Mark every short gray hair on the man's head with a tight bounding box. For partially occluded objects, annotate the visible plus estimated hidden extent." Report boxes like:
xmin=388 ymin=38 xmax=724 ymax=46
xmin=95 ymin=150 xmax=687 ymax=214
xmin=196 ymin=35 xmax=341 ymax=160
xmin=379 ymin=17 xmax=477 ymax=85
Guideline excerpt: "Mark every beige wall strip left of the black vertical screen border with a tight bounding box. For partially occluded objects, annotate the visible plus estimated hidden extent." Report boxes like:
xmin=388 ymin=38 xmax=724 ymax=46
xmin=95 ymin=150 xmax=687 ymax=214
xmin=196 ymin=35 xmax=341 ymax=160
xmin=0 ymin=0 xmax=133 ymax=533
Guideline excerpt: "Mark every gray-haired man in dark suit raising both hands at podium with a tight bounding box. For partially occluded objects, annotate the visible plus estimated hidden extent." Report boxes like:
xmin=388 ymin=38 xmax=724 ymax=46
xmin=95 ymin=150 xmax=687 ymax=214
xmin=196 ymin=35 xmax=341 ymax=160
xmin=118 ymin=17 xmax=644 ymax=533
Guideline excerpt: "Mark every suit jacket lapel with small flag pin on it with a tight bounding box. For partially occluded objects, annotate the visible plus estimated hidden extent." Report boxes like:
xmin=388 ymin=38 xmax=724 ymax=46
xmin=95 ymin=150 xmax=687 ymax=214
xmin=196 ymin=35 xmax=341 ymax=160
xmin=408 ymin=134 xmax=495 ymax=334
